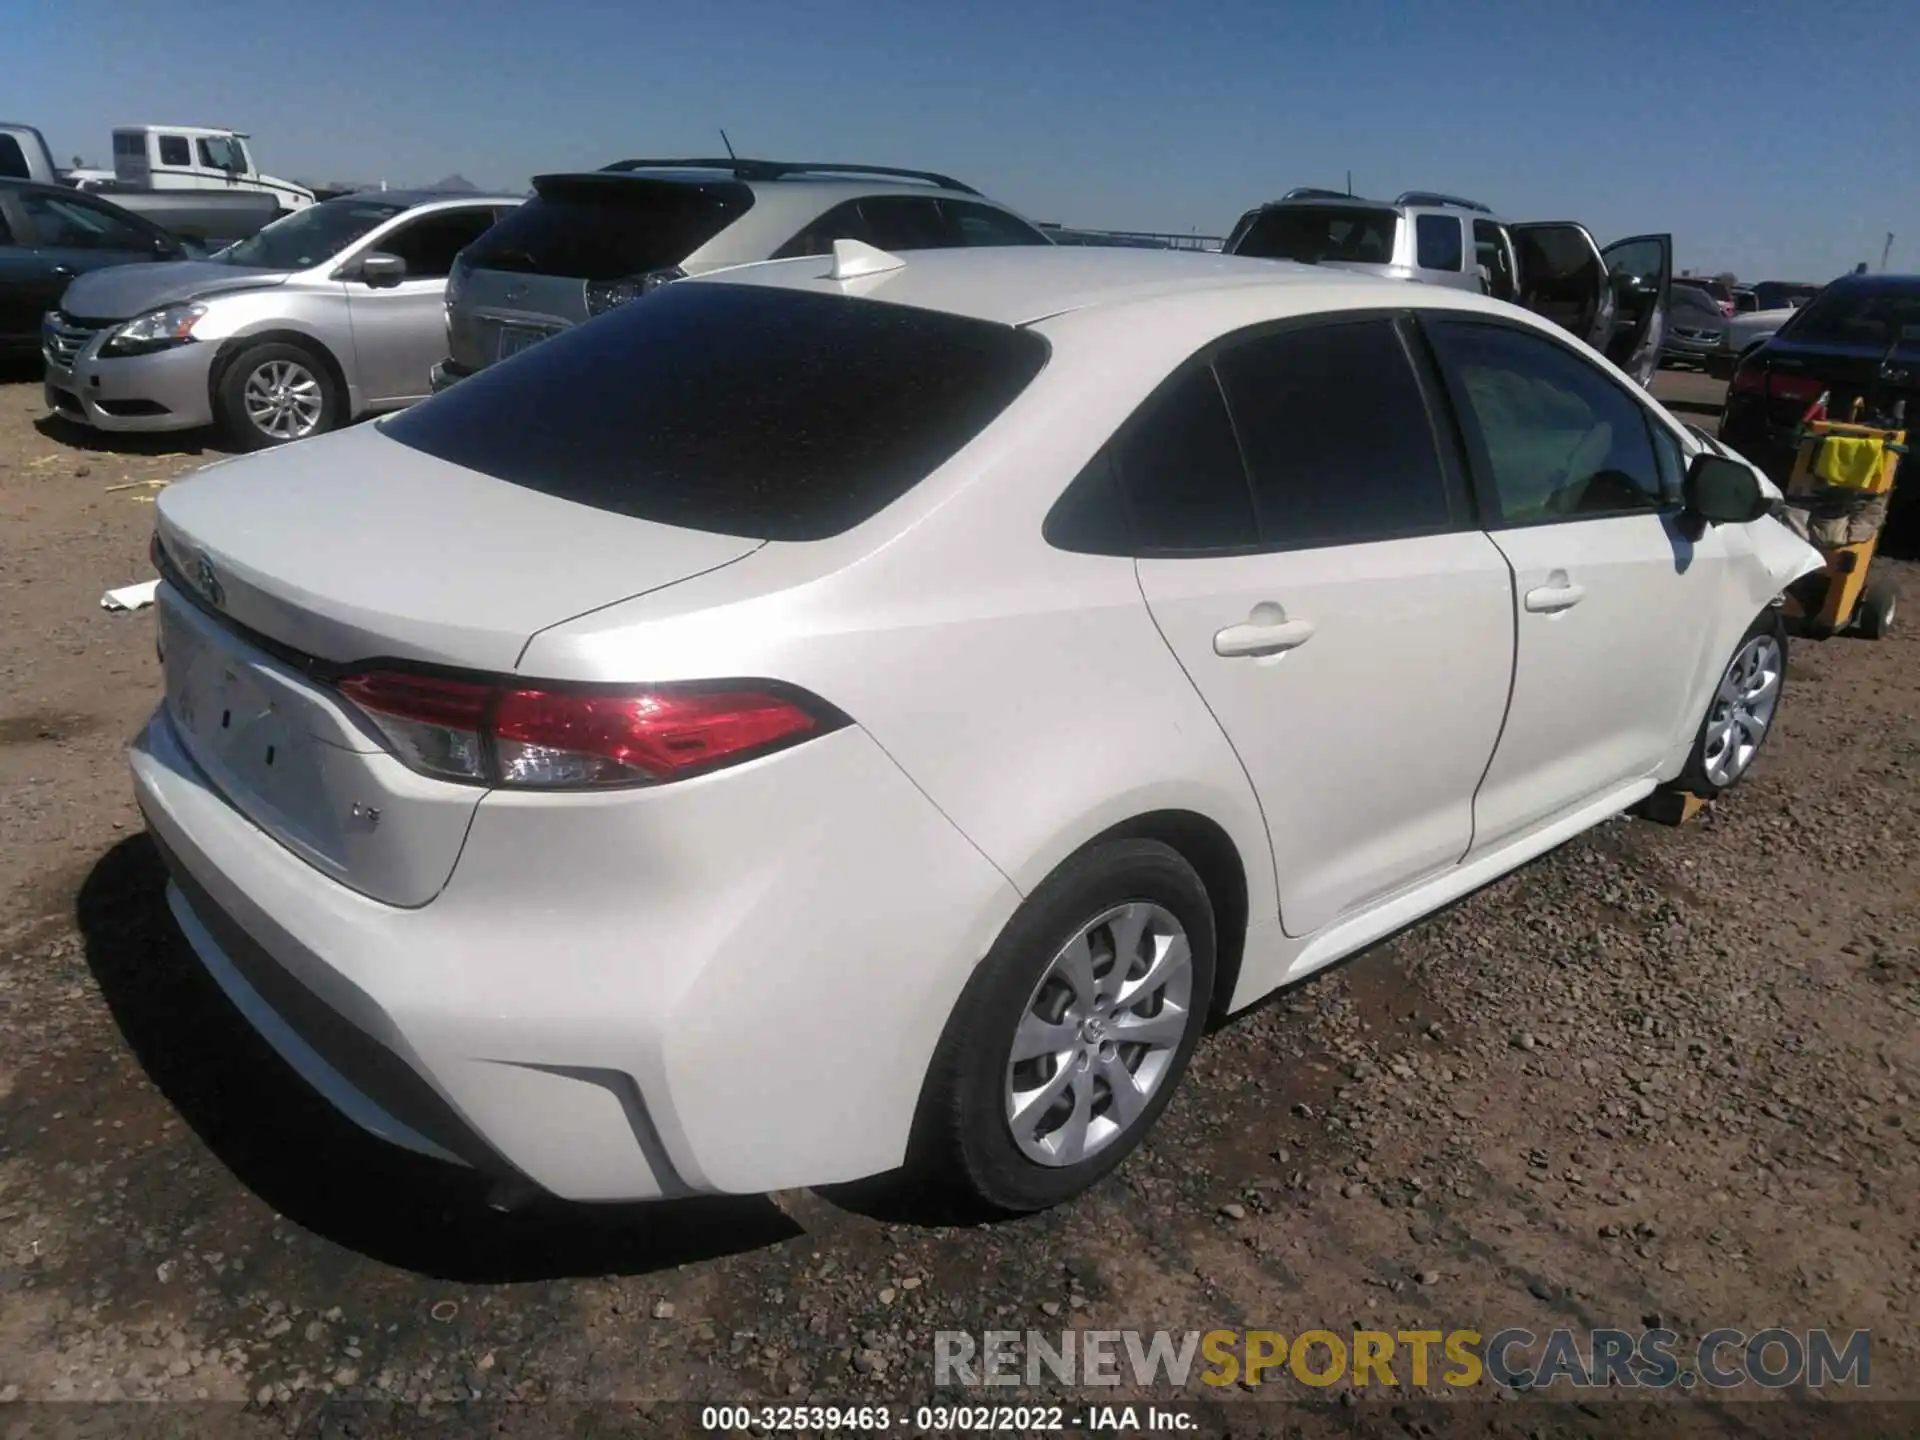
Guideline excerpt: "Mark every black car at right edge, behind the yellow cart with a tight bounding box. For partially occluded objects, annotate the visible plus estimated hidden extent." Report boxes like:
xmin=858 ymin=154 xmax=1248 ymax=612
xmin=1720 ymin=275 xmax=1920 ymax=532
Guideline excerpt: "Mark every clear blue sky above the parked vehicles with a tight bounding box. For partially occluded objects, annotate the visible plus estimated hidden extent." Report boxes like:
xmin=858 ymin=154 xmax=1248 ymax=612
xmin=11 ymin=0 xmax=1920 ymax=280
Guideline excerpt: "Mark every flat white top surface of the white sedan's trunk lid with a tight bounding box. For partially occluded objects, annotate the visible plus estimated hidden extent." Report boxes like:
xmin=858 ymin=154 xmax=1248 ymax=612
xmin=157 ymin=426 xmax=762 ymax=672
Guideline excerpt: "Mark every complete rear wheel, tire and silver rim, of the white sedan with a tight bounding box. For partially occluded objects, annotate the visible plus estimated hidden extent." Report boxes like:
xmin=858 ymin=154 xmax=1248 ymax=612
xmin=916 ymin=841 xmax=1213 ymax=1212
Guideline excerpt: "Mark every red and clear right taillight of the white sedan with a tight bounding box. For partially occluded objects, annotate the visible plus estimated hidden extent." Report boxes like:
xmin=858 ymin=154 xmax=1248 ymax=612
xmin=340 ymin=670 xmax=845 ymax=789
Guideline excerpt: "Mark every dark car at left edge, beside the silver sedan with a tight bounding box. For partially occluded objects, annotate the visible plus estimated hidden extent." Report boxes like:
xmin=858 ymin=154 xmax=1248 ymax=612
xmin=0 ymin=179 xmax=188 ymax=359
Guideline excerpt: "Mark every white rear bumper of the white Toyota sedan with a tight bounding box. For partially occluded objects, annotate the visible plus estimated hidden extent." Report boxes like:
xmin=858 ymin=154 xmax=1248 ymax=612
xmin=132 ymin=712 xmax=1018 ymax=1200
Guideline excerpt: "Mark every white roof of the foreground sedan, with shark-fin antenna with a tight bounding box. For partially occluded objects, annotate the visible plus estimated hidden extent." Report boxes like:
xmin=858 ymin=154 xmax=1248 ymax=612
xmin=695 ymin=246 xmax=1513 ymax=324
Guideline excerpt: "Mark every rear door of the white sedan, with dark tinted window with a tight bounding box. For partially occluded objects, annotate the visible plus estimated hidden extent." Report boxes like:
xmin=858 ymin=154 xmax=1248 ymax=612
xmin=1114 ymin=315 xmax=1513 ymax=952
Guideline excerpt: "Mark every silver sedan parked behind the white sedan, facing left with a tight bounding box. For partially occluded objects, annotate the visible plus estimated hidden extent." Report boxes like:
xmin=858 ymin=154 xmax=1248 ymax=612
xmin=40 ymin=190 xmax=520 ymax=449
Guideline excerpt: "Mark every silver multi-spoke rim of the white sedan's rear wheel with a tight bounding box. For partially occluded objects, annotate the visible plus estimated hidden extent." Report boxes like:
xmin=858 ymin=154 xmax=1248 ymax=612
xmin=1004 ymin=900 xmax=1194 ymax=1165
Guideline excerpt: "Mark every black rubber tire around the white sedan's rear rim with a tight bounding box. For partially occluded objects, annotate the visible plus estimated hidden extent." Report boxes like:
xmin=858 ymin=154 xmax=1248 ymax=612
xmin=912 ymin=839 xmax=1215 ymax=1213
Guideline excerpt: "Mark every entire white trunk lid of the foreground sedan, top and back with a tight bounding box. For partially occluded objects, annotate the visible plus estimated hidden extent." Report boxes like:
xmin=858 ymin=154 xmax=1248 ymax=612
xmin=157 ymin=426 xmax=762 ymax=906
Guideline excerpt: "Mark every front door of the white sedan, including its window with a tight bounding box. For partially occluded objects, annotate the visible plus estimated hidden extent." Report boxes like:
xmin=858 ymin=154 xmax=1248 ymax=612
xmin=1427 ymin=319 xmax=1726 ymax=852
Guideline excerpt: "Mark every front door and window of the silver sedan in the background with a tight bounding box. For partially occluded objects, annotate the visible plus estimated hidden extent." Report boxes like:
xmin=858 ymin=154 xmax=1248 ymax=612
xmin=336 ymin=205 xmax=497 ymax=409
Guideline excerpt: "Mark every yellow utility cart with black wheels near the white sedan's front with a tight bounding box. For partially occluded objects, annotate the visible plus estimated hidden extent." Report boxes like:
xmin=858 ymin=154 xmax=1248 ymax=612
xmin=1786 ymin=396 xmax=1907 ymax=639
